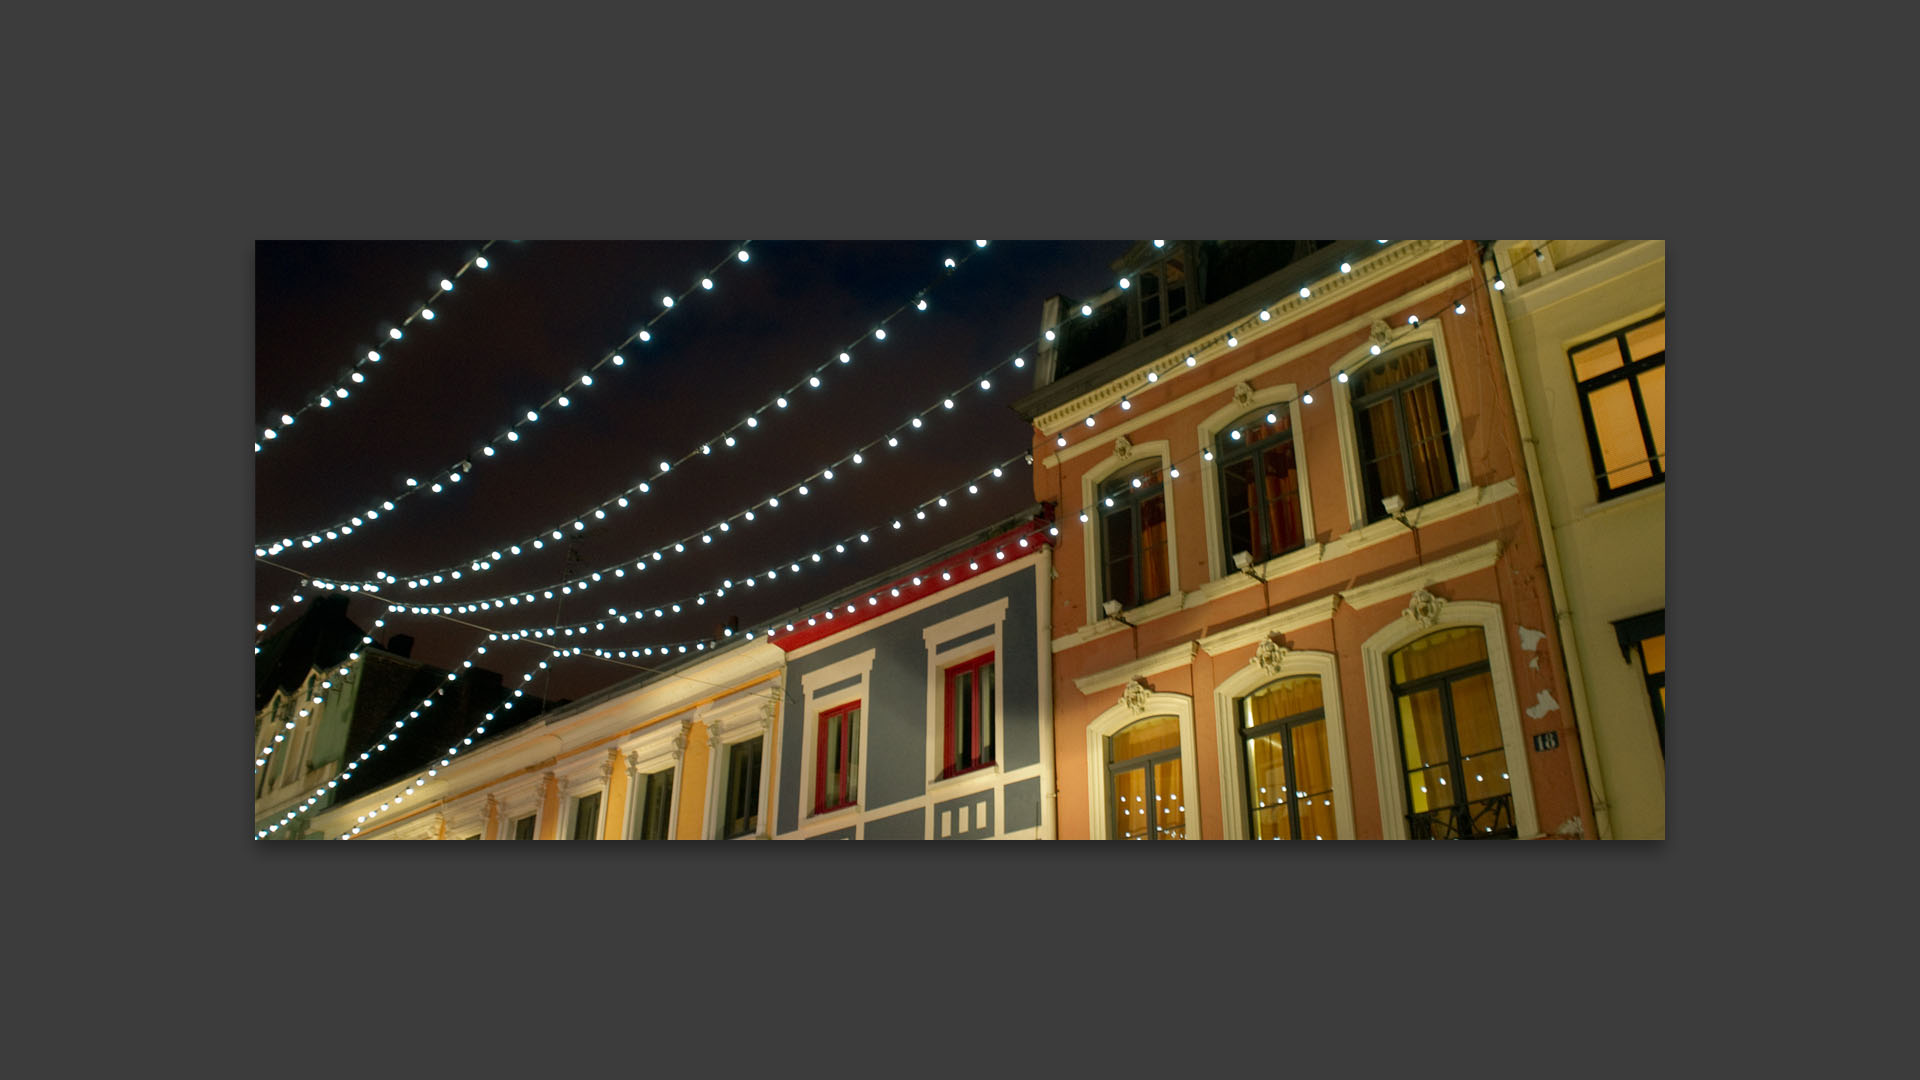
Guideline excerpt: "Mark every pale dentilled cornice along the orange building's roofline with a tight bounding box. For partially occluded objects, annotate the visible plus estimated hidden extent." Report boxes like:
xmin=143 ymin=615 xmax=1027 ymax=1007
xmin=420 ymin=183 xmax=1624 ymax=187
xmin=1033 ymin=240 xmax=1457 ymax=436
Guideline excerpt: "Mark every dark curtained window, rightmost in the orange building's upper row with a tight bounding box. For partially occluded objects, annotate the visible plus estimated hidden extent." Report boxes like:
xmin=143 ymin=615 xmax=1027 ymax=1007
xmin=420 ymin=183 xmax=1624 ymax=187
xmin=1352 ymin=342 xmax=1459 ymax=523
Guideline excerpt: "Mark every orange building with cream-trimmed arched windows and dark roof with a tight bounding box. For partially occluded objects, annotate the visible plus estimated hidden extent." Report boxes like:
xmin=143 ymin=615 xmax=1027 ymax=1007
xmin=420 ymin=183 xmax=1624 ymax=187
xmin=1016 ymin=240 xmax=1596 ymax=840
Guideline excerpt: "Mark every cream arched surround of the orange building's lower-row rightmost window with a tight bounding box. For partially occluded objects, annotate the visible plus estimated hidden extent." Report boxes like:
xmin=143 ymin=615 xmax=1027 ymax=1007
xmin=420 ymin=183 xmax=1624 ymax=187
xmin=1359 ymin=590 xmax=1540 ymax=840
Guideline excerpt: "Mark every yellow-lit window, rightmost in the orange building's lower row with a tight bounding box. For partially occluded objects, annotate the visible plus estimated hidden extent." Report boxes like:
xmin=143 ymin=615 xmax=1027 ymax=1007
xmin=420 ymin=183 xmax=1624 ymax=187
xmin=1388 ymin=626 xmax=1519 ymax=840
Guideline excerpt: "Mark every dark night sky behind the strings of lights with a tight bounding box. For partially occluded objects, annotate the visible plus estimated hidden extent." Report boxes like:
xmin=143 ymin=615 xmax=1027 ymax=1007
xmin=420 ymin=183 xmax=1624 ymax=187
xmin=253 ymin=240 xmax=1129 ymax=700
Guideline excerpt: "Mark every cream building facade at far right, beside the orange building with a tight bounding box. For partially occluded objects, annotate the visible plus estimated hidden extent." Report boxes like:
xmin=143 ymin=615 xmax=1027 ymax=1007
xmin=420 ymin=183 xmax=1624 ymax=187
xmin=1488 ymin=240 xmax=1667 ymax=840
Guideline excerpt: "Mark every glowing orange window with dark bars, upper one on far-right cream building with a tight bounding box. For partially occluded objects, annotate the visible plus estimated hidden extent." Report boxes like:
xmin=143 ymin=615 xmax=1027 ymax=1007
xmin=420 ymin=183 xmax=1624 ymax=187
xmin=1569 ymin=313 xmax=1667 ymax=500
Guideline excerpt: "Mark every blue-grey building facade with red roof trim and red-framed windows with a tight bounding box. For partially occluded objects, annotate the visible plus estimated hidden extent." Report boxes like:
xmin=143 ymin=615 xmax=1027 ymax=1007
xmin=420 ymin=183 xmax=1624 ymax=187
xmin=774 ymin=513 xmax=1054 ymax=840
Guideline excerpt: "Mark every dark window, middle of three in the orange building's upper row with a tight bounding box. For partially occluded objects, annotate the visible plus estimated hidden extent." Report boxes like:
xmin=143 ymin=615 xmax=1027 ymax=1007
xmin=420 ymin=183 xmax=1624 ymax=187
xmin=1213 ymin=404 xmax=1308 ymax=567
